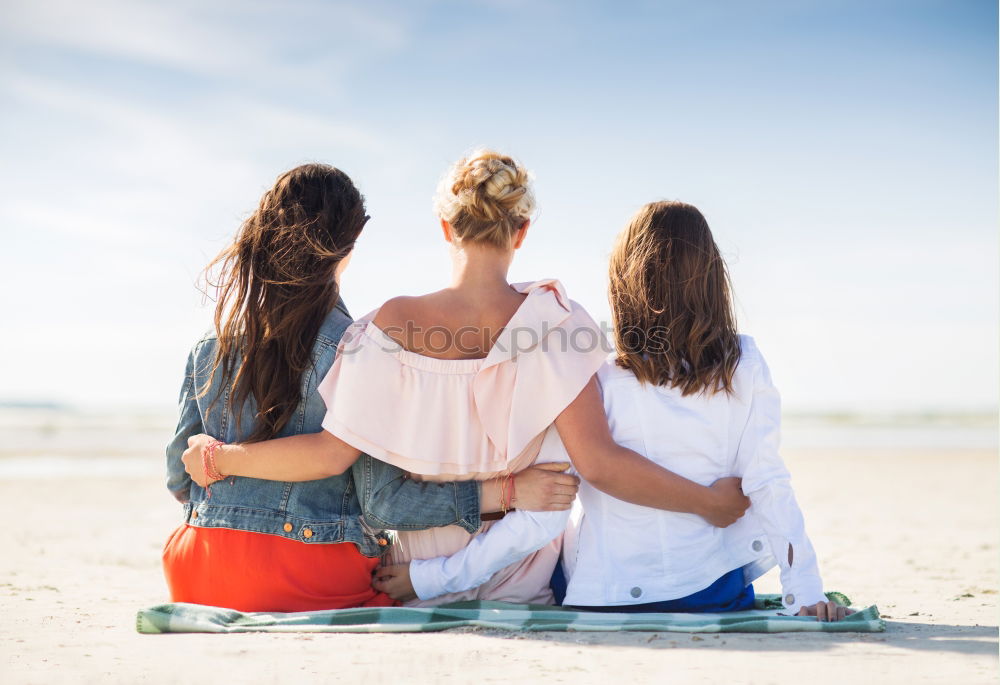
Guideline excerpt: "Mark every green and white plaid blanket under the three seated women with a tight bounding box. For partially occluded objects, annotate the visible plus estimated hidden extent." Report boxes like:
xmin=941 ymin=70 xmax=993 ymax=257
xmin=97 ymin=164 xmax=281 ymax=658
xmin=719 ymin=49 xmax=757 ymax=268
xmin=136 ymin=592 xmax=885 ymax=634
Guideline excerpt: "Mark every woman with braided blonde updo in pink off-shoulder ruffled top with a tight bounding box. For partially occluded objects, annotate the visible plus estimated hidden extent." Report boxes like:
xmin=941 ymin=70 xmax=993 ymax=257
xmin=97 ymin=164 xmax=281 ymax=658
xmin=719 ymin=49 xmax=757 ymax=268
xmin=185 ymin=151 xmax=746 ymax=605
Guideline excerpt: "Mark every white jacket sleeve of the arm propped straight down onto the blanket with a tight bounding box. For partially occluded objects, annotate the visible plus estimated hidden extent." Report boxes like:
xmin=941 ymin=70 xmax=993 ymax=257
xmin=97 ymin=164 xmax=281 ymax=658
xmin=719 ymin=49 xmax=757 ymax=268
xmin=736 ymin=347 xmax=826 ymax=614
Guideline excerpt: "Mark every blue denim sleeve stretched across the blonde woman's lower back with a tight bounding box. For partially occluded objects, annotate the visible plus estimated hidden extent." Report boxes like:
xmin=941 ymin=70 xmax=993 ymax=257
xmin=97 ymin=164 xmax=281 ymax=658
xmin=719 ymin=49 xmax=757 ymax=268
xmin=351 ymin=454 xmax=481 ymax=533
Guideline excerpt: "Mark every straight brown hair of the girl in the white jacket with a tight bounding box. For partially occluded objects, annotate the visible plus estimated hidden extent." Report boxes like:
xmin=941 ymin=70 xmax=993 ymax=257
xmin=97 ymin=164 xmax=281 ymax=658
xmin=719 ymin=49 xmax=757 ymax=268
xmin=609 ymin=202 xmax=740 ymax=395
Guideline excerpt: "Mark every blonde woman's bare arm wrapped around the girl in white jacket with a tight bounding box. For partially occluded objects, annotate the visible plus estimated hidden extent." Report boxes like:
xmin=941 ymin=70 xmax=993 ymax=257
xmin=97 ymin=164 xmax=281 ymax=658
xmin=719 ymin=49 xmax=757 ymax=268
xmin=555 ymin=378 xmax=749 ymax=528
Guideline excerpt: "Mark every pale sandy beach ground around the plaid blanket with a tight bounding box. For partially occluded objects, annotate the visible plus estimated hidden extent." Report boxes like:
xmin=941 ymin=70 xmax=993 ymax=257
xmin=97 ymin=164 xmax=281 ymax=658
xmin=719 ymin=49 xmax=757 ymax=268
xmin=0 ymin=414 xmax=998 ymax=684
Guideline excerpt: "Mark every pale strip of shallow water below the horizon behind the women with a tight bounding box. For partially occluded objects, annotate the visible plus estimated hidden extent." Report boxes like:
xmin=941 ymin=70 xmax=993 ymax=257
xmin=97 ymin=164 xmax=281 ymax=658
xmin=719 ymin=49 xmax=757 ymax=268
xmin=0 ymin=408 xmax=998 ymax=480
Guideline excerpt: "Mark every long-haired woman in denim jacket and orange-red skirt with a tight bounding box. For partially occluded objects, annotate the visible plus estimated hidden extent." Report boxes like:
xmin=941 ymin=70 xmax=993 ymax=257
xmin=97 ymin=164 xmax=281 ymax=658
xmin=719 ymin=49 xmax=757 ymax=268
xmin=163 ymin=164 xmax=577 ymax=611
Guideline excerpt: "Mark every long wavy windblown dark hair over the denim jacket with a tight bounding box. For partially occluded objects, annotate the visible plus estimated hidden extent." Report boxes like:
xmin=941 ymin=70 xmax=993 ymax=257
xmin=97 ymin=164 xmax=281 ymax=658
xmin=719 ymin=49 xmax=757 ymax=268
xmin=201 ymin=164 xmax=368 ymax=442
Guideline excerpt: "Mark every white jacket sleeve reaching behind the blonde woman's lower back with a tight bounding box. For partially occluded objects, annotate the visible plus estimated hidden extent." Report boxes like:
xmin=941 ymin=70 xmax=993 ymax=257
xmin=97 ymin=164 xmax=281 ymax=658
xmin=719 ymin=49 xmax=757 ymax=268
xmin=410 ymin=426 xmax=570 ymax=599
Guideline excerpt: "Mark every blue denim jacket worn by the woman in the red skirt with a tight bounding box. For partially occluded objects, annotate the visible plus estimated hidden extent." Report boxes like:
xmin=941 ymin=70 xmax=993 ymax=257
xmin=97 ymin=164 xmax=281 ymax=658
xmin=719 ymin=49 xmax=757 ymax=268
xmin=167 ymin=300 xmax=480 ymax=557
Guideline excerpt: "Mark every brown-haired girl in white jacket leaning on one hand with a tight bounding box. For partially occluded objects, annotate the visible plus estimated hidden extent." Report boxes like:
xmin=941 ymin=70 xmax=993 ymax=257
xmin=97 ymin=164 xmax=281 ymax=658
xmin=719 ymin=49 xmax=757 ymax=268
xmin=563 ymin=202 xmax=851 ymax=620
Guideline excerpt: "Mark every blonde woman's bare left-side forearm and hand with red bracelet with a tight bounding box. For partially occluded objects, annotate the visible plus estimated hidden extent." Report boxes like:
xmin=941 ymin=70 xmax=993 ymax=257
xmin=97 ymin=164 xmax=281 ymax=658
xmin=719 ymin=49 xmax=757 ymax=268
xmin=183 ymin=431 xmax=361 ymax=485
